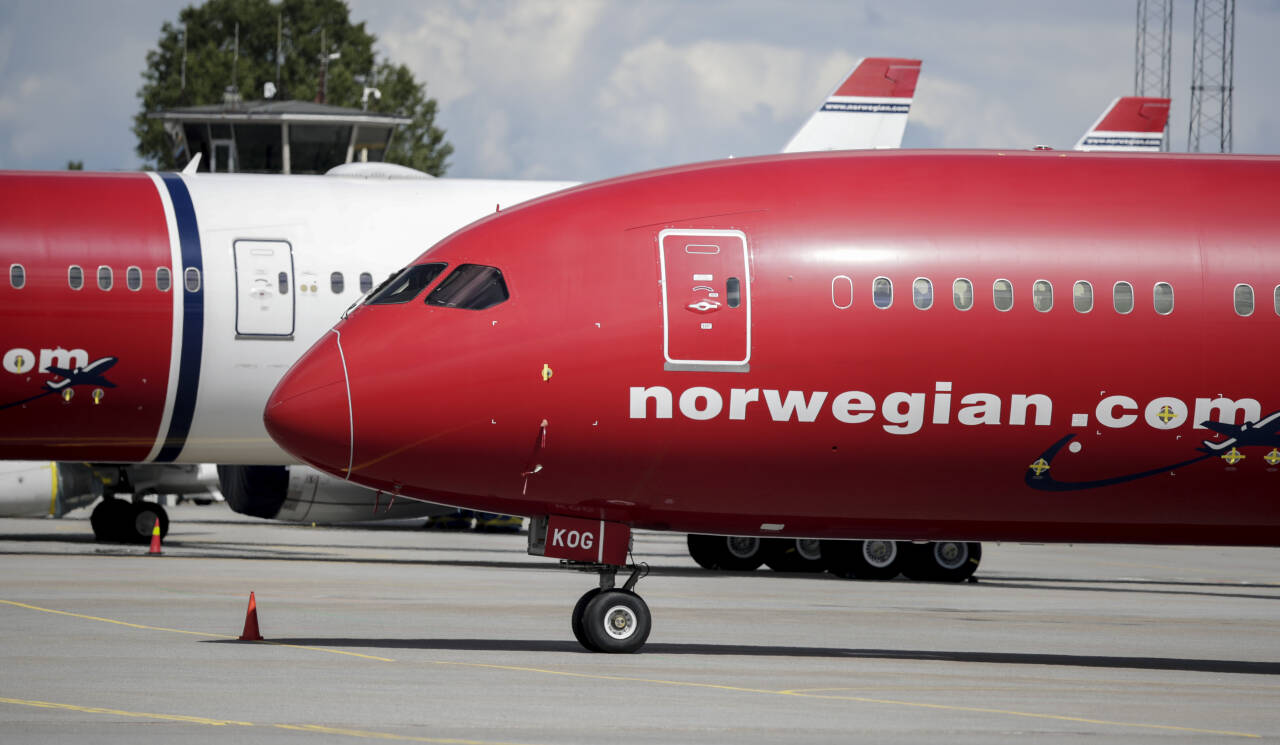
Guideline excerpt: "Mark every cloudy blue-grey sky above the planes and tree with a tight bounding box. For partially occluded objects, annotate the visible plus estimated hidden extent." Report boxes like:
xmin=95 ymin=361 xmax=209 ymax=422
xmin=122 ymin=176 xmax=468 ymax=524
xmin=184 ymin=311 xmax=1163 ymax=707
xmin=0 ymin=0 xmax=1280 ymax=179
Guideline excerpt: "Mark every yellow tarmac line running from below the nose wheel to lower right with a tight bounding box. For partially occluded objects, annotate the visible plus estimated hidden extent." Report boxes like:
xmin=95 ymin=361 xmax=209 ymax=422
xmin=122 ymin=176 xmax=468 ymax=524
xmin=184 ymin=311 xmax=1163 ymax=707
xmin=434 ymin=662 xmax=1262 ymax=739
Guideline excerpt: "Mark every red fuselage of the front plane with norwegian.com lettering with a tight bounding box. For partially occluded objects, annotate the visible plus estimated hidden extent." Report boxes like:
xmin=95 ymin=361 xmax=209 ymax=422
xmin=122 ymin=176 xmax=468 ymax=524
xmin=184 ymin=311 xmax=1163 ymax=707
xmin=266 ymin=151 xmax=1280 ymax=545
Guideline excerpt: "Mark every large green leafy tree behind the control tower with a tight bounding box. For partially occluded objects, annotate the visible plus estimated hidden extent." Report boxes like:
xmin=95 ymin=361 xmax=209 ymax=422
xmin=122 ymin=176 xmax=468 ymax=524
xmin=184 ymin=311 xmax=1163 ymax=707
xmin=133 ymin=0 xmax=453 ymax=175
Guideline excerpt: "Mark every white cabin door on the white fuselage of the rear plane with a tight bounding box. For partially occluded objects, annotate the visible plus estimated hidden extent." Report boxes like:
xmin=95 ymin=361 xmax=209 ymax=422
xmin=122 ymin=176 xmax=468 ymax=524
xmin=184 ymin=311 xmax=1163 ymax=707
xmin=233 ymin=241 xmax=294 ymax=339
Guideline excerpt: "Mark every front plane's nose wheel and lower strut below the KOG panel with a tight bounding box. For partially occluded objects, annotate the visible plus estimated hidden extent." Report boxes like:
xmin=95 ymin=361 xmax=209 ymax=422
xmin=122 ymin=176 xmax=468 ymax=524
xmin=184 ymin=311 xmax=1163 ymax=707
xmin=570 ymin=565 xmax=653 ymax=653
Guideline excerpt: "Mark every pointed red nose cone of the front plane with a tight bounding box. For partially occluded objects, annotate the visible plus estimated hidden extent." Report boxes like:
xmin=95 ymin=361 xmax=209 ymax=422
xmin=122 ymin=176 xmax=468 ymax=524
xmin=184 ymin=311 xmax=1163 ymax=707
xmin=262 ymin=333 xmax=352 ymax=475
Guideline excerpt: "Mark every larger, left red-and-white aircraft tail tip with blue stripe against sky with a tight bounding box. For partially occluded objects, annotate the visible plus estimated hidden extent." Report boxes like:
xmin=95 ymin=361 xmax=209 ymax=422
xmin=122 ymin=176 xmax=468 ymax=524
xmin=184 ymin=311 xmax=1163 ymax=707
xmin=782 ymin=58 xmax=920 ymax=152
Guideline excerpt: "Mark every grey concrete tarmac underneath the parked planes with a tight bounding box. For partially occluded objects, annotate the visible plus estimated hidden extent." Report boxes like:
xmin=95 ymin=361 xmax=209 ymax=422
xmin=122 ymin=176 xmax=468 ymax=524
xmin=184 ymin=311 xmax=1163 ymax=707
xmin=0 ymin=506 xmax=1280 ymax=745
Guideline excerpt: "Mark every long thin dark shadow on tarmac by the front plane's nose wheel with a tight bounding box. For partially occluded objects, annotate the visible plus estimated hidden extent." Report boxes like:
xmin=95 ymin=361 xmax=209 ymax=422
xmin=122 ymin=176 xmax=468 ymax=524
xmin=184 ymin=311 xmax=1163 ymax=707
xmin=201 ymin=637 xmax=1280 ymax=675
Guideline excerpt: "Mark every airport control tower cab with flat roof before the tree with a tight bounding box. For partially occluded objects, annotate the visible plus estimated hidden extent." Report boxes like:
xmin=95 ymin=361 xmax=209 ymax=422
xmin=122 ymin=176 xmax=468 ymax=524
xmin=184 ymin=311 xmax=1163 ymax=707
xmin=147 ymin=100 xmax=411 ymax=174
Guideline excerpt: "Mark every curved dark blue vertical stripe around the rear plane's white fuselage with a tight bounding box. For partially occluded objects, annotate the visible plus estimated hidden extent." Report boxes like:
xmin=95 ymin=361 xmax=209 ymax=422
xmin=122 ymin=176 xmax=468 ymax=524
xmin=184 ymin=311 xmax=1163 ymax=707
xmin=155 ymin=173 xmax=205 ymax=462
